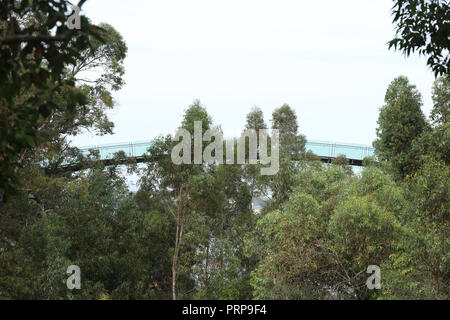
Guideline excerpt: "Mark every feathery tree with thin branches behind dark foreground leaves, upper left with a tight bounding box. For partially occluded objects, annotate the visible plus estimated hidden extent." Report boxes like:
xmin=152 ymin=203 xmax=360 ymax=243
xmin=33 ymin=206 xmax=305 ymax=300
xmin=29 ymin=23 xmax=127 ymax=174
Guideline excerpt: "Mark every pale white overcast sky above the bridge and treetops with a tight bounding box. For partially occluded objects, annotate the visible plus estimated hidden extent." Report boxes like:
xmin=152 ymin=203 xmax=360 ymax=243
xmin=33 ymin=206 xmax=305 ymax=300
xmin=72 ymin=0 xmax=434 ymax=147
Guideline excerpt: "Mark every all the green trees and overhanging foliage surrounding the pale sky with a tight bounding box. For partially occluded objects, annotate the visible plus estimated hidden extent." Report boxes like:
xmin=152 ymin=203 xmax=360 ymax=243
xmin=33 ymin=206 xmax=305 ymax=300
xmin=0 ymin=0 xmax=450 ymax=300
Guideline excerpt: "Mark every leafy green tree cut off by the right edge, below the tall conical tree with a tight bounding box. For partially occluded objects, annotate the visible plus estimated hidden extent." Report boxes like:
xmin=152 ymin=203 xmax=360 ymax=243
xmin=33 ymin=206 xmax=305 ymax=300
xmin=406 ymin=158 xmax=450 ymax=299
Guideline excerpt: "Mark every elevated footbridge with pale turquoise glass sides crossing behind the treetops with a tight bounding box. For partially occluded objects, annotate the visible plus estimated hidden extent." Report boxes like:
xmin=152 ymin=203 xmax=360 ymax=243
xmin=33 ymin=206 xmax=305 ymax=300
xmin=66 ymin=140 xmax=374 ymax=171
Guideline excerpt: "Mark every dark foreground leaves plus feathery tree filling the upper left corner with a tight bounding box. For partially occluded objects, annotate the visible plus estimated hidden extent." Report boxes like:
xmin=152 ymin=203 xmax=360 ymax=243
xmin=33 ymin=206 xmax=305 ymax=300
xmin=0 ymin=0 xmax=127 ymax=200
